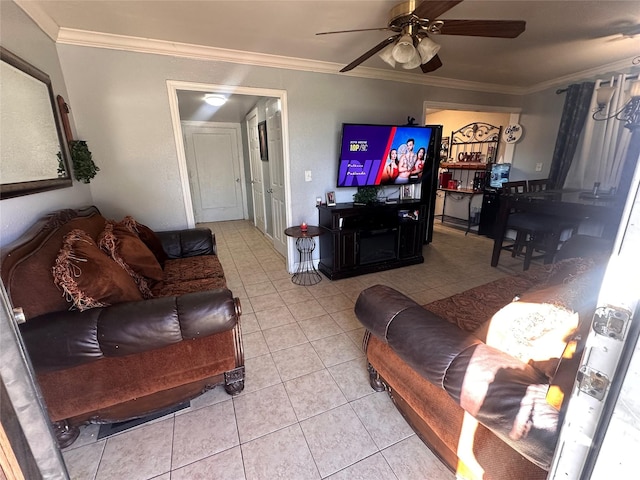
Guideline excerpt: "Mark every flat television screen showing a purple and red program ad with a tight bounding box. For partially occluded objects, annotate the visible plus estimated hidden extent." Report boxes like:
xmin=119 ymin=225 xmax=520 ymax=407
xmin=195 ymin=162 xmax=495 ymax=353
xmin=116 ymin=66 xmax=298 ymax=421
xmin=337 ymin=123 xmax=435 ymax=187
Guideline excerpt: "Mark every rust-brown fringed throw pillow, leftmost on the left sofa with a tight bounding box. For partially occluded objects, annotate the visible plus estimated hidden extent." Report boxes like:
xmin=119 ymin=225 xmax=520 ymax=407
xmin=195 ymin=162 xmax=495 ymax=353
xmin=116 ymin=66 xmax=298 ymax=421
xmin=53 ymin=229 xmax=142 ymax=311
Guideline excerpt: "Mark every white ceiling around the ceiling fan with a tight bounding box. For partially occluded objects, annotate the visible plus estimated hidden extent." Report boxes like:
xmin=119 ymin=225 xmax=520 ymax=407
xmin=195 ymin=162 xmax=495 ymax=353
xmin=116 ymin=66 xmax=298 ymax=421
xmin=16 ymin=0 xmax=640 ymax=89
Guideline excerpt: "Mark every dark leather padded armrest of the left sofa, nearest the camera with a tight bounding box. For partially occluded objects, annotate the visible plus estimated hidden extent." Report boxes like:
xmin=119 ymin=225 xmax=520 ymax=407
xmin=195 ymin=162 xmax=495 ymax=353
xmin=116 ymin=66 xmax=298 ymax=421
xmin=20 ymin=289 xmax=240 ymax=371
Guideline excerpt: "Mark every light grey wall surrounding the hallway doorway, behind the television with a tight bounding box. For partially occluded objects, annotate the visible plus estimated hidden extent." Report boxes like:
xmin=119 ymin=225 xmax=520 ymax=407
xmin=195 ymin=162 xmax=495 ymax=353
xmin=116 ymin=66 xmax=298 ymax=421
xmin=58 ymin=45 xmax=519 ymax=237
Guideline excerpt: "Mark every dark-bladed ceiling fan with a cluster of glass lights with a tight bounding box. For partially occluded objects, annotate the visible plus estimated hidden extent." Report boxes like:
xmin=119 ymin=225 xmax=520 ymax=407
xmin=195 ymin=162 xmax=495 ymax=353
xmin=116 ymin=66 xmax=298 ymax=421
xmin=316 ymin=0 xmax=526 ymax=73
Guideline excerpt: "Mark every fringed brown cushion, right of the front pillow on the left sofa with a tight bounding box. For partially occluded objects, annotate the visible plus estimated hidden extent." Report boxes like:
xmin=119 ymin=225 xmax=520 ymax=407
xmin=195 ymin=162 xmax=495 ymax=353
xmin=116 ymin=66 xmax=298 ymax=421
xmin=98 ymin=221 xmax=164 ymax=298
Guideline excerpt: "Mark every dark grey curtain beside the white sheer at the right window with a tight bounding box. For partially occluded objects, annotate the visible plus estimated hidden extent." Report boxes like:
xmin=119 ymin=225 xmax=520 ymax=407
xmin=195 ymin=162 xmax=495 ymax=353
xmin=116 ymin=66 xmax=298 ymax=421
xmin=549 ymin=82 xmax=595 ymax=188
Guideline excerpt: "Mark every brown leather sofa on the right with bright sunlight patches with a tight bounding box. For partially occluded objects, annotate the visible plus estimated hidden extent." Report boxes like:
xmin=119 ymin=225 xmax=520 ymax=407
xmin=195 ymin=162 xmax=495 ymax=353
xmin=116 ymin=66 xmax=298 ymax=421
xmin=355 ymin=253 xmax=604 ymax=480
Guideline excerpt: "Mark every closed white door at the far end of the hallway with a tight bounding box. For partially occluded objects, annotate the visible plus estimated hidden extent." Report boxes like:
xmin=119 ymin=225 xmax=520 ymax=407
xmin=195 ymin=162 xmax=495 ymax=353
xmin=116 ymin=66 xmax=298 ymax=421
xmin=183 ymin=123 xmax=247 ymax=223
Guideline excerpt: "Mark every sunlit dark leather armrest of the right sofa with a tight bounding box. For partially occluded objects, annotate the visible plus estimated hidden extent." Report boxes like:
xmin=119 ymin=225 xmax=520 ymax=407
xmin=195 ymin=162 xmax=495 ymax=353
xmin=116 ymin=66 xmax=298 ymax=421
xmin=355 ymin=285 xmax=560 ymax=469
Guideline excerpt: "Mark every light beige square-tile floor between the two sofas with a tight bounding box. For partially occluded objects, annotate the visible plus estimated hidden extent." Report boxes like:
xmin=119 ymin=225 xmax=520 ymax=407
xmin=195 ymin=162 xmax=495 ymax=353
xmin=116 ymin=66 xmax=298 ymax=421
xmin=63 ymin=221 xmax=522 ymax=480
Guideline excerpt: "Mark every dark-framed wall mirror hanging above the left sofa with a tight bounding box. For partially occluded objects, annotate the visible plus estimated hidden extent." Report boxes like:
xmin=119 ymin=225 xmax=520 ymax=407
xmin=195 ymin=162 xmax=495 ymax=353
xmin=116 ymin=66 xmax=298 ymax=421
xmin=0 ymin=47 xmax=72 ymax=199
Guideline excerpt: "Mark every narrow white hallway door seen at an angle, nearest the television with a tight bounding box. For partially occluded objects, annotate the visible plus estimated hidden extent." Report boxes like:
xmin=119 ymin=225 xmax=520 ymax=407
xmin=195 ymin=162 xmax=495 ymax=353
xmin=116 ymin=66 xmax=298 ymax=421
xmin=266 ymin=98 xmax=287 ymax=258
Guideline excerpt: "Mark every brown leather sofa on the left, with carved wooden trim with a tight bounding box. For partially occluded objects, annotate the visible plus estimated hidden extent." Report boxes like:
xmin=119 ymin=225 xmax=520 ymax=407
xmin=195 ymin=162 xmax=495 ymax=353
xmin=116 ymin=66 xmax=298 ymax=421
xmin=2 ymin=207 xmax=244 ymax=446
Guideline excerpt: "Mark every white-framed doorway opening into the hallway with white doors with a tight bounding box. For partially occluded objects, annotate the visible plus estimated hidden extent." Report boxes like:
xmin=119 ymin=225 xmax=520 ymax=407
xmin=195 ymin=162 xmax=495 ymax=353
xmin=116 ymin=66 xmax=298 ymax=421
xmin=167 ymin=80 xmax=293 ymax=259
